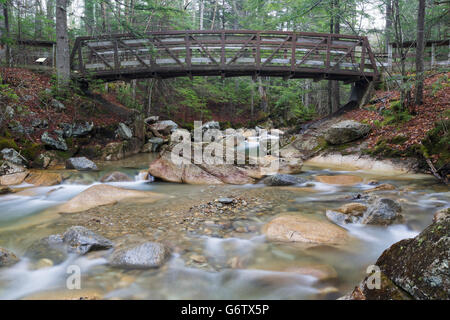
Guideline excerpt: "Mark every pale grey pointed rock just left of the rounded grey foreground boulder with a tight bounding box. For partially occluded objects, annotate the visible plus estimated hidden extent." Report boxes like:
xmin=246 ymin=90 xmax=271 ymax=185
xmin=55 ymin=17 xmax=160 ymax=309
xmin=63 ymin=226 xmax=113 ymax=254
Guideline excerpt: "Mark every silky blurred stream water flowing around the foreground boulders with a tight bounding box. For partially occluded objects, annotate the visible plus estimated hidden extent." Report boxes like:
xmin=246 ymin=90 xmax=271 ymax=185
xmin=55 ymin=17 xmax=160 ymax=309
xmin=0 ymin=155 xmax=450 ymax=299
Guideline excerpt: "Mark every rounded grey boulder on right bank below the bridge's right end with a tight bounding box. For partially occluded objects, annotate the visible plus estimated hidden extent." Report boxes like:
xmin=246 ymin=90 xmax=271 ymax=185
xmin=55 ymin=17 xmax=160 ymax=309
xmin=324 ymin=120 xmax=371 ymax=144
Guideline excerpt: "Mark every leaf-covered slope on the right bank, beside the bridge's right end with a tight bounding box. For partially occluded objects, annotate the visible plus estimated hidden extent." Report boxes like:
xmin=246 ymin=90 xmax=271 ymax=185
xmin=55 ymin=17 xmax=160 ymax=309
xmin=344 ymin=72 xmax=450 ymax=158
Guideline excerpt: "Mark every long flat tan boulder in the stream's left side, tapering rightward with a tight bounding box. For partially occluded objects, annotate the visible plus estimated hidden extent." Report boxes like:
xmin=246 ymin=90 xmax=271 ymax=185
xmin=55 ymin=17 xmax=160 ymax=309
xmin=57 ymin=184 xmax=163 ymax=213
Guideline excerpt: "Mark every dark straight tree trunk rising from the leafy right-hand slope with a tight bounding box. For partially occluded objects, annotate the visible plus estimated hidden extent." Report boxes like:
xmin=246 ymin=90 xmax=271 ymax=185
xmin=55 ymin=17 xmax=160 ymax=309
xmin=416 ymin=0 xmax=425 ymax=105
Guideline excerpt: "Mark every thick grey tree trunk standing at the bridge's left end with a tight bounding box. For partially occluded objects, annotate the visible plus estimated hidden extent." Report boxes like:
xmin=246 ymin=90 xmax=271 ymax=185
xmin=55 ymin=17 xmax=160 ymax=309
xmin=56 ymin=0 xmax=70 ymax=87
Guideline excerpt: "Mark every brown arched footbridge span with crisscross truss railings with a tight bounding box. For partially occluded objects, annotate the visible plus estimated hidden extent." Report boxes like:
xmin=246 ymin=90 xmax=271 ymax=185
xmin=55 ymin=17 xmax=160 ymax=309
xmin=71 ymin=30 xmax=378 ymax=81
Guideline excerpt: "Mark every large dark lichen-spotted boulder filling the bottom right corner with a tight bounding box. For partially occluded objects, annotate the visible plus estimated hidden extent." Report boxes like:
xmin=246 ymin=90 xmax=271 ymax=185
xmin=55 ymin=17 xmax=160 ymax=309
xmin=344 ymin=211 xmax=450 ymax=300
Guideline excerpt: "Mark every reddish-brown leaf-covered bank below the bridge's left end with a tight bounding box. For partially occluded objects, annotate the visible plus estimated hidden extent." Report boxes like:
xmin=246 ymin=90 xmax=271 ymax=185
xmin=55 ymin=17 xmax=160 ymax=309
xmin=0 ymin=68 xmax=129 ymax=142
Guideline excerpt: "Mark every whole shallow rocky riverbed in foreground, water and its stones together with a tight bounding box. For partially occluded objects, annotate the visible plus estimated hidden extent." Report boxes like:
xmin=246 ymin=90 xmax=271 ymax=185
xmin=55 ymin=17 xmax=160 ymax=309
xmin=0 ymin=151 xmax=449 ymax=299
